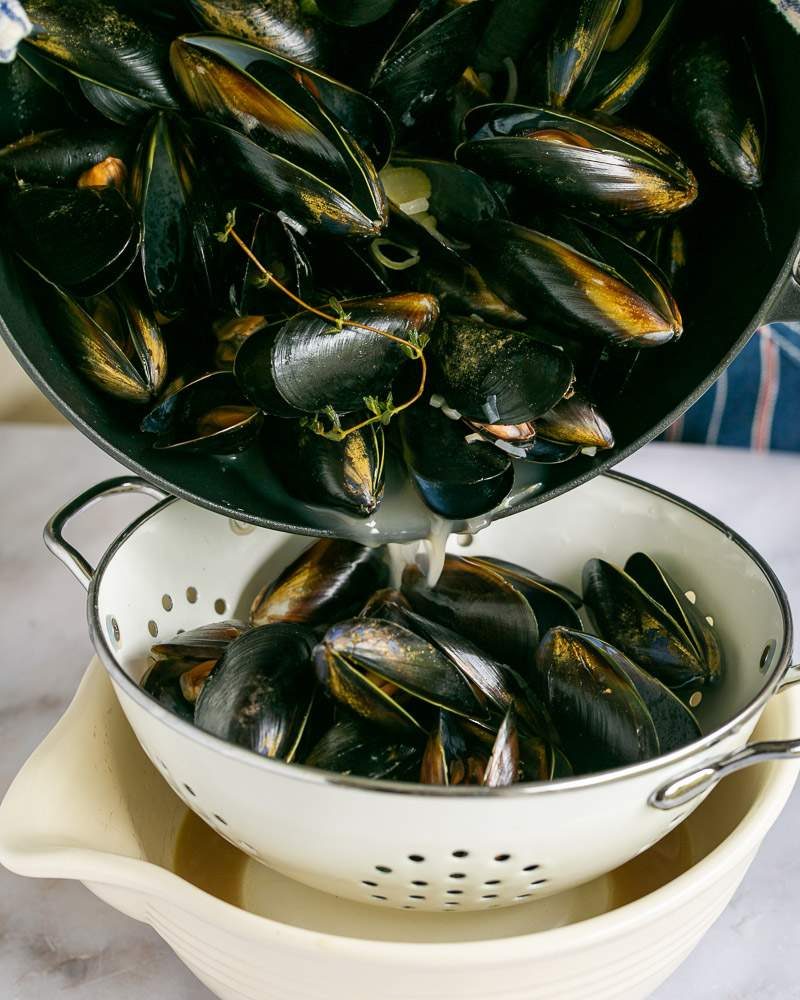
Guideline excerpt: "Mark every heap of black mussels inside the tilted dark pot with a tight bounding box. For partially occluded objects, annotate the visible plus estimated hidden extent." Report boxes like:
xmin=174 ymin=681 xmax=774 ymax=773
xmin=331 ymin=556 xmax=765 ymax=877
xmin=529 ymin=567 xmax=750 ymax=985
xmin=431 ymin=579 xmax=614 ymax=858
xmin=0 ymin=0 xmax=765 ymax=520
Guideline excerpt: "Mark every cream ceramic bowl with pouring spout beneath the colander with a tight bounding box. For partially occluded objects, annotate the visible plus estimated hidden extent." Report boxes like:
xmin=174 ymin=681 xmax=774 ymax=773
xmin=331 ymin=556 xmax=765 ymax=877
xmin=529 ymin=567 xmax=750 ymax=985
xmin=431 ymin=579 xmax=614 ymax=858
xmin=0 ymin=661 xmax=800 ymax=1000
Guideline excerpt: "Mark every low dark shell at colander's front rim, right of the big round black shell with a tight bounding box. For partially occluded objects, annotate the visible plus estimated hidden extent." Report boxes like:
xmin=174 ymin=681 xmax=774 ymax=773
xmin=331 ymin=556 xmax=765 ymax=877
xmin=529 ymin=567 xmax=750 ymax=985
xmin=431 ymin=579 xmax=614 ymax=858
xmin=304 ymin=717 xmax=421 ymax=781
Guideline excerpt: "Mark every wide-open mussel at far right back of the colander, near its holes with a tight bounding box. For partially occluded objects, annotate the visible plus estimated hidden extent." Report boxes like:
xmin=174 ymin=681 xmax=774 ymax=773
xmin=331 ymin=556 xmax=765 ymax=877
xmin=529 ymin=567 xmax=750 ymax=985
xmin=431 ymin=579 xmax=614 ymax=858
xmin=583 ymin=555 xmax=723 ymax=704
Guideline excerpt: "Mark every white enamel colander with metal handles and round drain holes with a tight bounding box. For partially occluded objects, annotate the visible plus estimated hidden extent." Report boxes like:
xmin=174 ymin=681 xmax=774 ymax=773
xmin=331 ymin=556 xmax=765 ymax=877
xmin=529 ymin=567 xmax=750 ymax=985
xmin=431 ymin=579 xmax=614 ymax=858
xmin=45 ymin=474 xmax=800 ymax=910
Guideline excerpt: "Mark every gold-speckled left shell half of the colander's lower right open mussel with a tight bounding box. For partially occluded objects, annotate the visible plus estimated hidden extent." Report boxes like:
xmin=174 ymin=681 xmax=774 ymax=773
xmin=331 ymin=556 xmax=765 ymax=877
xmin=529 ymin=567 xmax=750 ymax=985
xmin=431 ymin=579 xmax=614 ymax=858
xmin=536 ymin=628 xmax=660 ymax=773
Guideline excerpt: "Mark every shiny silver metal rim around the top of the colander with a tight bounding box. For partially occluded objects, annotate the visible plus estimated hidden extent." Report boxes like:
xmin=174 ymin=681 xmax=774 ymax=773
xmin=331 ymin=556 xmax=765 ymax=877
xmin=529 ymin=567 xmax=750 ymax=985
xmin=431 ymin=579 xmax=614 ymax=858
xmin=87 ymin=472 xmax=793 ymax=801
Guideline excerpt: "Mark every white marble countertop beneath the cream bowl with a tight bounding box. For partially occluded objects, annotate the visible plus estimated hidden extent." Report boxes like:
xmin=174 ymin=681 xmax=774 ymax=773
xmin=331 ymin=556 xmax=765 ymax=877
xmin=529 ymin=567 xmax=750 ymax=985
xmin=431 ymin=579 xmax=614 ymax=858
xmin=0 ymin=425 xmax=800 ymax=1000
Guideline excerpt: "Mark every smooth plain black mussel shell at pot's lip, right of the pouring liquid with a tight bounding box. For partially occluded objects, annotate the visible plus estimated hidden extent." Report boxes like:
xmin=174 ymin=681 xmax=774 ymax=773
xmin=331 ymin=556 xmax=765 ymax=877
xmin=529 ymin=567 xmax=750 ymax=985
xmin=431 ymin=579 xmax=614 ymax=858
xmin=400 ymin=402 xmax=514 ymax=521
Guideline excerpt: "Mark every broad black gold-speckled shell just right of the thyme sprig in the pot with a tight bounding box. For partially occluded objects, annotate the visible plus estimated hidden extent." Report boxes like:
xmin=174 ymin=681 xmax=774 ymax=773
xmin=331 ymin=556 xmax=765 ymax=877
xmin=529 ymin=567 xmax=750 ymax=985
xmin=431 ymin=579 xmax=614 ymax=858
xmin=431 ymin=316 xmax=575 ymax=424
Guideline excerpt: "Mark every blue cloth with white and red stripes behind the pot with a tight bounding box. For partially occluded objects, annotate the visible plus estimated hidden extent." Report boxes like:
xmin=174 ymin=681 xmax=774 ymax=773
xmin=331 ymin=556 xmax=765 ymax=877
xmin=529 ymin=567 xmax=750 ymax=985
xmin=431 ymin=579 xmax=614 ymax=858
xmin=663 ymin=323 xmax=800 ymax=451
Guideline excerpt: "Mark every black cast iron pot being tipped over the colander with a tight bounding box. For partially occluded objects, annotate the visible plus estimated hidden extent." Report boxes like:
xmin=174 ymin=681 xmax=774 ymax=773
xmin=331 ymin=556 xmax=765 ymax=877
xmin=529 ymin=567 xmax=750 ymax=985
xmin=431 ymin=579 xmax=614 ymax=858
xmin=0 ymin=0 xmax=800 ymax=536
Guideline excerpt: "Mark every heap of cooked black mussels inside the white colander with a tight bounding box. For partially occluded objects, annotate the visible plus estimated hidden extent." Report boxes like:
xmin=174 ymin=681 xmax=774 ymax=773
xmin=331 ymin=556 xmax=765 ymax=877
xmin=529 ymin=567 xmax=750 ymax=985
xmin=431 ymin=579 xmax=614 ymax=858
xmin=142 ymin=539 xmax=724 ymax=787
